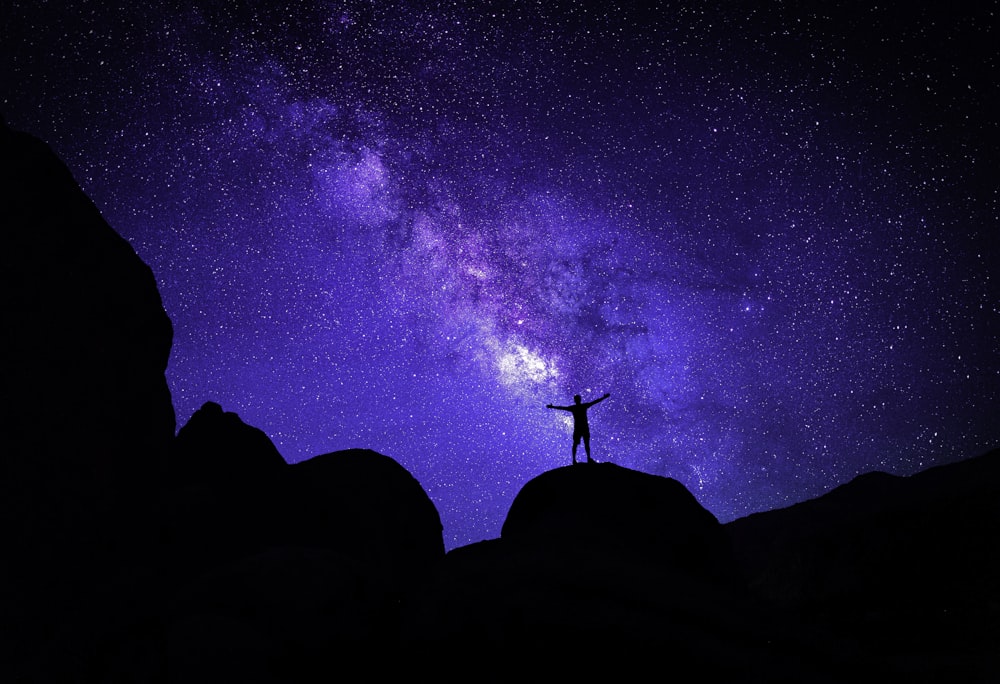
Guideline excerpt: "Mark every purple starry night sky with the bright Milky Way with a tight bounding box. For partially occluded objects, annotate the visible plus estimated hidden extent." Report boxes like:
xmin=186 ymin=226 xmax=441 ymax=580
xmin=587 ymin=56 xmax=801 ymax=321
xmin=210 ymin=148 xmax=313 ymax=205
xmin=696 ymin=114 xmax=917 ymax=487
xmin=0 ymin=0 xmax=1000 ymax=548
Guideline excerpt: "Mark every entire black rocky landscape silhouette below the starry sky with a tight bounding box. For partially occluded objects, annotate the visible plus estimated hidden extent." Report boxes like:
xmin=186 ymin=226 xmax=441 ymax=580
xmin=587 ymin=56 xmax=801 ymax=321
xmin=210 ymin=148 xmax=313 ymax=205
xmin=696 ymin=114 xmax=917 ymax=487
xmin=0 ymin=127 xmax=1000 ymax=684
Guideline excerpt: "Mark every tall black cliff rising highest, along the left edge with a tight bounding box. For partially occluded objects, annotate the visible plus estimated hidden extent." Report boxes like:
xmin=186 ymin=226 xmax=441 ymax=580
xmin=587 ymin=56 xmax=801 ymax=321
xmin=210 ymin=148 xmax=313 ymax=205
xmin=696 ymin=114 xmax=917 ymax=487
xmin=0 ymin=124 xmax=174 ymax=659
